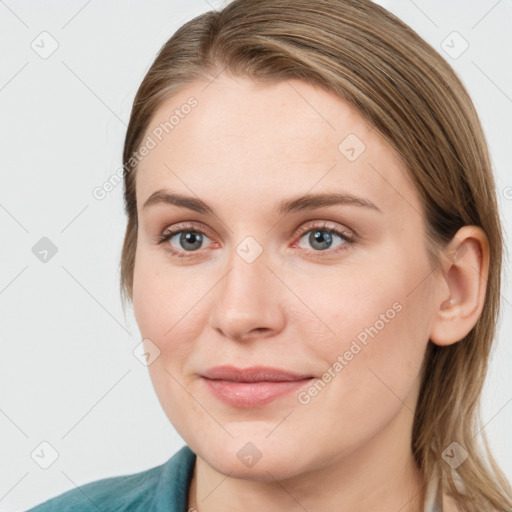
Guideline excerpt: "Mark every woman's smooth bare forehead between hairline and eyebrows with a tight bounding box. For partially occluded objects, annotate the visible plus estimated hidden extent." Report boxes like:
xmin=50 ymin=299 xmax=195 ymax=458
xmin=136 ymin=74 xmax=418 ymax=216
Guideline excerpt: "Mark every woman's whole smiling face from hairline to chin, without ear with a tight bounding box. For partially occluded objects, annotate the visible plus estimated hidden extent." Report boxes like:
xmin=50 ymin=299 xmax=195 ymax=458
xmin=133 ymin=75 xmax=436 ymax=480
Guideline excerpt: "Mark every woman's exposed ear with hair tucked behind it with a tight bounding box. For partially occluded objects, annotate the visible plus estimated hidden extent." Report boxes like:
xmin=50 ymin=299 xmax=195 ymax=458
xmin=430 ymin=226 xmax=489 ymax=346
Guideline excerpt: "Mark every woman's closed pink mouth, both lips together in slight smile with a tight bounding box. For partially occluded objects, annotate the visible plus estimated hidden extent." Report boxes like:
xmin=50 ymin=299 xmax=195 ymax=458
xmin=201 ymin=366 xmax=315 ymax=409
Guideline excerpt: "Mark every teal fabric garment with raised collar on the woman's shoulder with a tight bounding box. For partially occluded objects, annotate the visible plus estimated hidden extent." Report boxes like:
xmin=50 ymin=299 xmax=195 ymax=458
xmin=26 ymin=446 xmax=195 ymax=512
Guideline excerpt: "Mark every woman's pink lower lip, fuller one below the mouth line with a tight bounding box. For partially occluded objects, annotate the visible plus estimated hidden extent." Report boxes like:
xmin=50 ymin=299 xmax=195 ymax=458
xmin=203 ymin=377 xmax=313 ymax=409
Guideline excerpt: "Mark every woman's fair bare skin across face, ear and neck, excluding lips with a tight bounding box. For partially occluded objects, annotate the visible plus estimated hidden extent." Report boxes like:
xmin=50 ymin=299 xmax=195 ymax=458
xmin=133 ymin=74 xmax=488 ymax=512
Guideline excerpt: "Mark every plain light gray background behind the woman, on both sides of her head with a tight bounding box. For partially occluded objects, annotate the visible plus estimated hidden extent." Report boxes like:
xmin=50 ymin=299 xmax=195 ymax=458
xmin=0 ymin=0 xmax=512 ymax=511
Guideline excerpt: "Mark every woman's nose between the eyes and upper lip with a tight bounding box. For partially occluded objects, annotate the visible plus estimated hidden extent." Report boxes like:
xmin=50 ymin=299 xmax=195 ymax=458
xmin=210 ymin=245 xmax=289 ymax=341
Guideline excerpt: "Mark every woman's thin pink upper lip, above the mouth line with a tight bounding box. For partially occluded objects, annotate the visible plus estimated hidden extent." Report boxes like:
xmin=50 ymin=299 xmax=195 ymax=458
xmin=201 ymin=365 xmax=312 ymax=382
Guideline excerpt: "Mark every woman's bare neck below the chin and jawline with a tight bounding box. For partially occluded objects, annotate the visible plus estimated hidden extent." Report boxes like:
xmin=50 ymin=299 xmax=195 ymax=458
xmin=188 ymin=408 xmax=425 ymax=512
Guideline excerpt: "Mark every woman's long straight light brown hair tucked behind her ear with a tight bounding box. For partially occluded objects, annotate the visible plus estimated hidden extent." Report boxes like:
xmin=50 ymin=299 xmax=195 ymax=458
xmin=121 ymin=0 xmax=512 ymax=512
